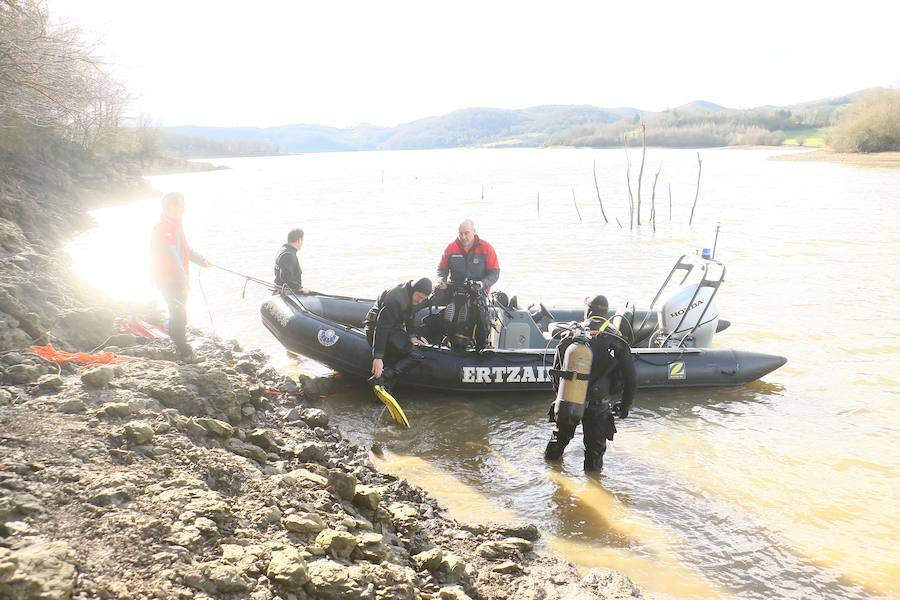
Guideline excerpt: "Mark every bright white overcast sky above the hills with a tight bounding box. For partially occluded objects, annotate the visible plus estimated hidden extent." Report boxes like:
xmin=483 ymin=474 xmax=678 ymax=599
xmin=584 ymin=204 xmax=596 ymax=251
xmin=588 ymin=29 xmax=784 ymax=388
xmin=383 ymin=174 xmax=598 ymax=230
xmin=49 ymin=0 xmax=900 ymax=126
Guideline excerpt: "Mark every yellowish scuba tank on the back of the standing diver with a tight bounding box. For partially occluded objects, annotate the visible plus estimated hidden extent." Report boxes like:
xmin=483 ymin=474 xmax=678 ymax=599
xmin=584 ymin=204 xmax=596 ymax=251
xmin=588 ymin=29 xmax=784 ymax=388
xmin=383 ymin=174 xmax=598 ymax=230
xmin=553 ymin=329 xmax=594 ymax=426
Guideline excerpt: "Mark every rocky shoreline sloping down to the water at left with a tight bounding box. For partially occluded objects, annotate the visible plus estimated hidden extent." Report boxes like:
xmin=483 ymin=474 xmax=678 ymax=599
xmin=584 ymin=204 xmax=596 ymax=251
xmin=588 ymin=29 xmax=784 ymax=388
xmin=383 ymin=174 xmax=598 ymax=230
xmin=0 ymin=157 xmax=642 ymax=600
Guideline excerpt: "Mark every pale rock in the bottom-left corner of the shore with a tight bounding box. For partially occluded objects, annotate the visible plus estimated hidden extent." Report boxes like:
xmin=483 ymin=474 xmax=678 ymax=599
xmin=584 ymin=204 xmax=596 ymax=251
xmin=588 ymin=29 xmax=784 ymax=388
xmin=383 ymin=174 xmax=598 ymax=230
xmin=0 ymin=541 xmax=76 ymax=600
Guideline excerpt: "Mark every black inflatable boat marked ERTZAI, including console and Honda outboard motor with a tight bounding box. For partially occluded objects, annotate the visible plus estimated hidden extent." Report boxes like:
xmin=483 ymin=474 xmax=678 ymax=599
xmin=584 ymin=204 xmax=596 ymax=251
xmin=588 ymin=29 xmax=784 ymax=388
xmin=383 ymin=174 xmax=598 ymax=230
xmin=260 ymin=256 xmax=787 ymax=393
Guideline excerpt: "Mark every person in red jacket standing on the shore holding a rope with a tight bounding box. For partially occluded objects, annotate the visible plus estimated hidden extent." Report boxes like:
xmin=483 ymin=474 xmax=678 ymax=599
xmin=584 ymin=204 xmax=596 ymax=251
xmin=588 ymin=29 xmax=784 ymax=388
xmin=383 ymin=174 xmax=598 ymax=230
xmin=150 ymin=192 xmax=212 ymax=361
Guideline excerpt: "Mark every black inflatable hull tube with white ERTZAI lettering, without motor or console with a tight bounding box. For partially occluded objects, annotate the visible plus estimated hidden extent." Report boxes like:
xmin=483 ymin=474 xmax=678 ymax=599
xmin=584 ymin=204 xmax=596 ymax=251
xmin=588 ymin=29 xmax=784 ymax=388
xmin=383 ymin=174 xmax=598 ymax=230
xmin=260 ymin=296 xmax=787 ymax=393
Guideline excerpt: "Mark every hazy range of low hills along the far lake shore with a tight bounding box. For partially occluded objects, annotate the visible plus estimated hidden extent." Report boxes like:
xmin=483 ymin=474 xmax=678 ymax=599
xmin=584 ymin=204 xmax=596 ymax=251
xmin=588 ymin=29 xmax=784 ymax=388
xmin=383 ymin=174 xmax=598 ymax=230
xmin=160 ymin=92 xmax=862 ymax=157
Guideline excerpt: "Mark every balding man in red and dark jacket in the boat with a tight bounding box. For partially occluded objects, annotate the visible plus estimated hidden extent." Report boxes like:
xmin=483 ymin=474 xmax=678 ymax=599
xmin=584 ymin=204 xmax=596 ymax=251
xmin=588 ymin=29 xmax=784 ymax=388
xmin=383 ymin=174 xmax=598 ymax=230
xmin=437 ymin=219 xmax=500 ymax=292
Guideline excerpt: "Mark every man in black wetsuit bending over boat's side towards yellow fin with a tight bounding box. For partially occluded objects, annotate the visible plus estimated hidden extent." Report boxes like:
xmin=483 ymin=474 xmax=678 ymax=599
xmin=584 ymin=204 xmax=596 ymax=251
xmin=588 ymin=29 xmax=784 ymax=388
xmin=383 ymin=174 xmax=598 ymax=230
xmin=365 ymin=277 xmax=431 ymax=387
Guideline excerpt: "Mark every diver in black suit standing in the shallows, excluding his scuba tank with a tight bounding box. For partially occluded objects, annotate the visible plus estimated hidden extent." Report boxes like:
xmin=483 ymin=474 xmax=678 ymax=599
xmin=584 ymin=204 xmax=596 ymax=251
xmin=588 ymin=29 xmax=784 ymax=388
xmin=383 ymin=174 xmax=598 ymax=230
xmin=544 ymin=296 xmax=637 ymax=471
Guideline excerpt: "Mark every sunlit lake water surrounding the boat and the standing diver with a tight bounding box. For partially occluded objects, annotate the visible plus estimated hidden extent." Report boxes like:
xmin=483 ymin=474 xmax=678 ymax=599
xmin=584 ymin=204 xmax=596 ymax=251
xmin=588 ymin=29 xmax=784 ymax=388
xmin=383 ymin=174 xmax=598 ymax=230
xmin=69 ymin=149 xmax=900 ymax=598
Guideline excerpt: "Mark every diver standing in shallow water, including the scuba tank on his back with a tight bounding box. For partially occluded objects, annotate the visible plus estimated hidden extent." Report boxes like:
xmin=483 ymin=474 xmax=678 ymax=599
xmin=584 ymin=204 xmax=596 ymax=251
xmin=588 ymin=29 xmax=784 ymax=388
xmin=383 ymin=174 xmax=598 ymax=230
xmin=544 ymin=296 xmax=637 ymax=471
